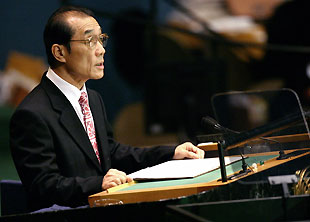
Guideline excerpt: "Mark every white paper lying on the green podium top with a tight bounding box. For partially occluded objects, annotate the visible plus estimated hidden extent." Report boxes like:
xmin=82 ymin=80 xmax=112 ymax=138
xmin=128 ymin=157 xmax=241 ymax=180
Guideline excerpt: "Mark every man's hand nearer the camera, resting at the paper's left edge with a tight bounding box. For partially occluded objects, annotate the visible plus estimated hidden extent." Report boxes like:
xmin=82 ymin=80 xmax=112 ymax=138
xmin=101 ymin=169 xmax=132 ymax=190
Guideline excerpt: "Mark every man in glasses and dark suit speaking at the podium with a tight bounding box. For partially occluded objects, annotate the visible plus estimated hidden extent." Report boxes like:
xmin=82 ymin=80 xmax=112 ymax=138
xmin=10 ymin=4 xmax=204 ymax=210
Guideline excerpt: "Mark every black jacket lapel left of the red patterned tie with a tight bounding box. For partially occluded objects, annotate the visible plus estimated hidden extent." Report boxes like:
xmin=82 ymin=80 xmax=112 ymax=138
xmin=41 ymin=75 xmax=102 ymax=171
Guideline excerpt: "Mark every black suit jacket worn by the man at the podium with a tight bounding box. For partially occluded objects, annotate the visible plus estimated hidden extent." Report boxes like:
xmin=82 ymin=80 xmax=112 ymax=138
xmin=10 ymin=75 xmax=174 ymax=209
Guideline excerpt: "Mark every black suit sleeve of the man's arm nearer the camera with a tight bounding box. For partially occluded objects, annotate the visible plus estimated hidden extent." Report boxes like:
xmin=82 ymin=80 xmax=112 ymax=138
xmin=10 ymin=110 xmax=103 ymax=209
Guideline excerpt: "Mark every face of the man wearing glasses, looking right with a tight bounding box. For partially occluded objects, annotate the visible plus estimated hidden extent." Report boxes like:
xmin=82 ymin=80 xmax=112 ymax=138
xmin=65 ymin=16 xmax=105 ymax=84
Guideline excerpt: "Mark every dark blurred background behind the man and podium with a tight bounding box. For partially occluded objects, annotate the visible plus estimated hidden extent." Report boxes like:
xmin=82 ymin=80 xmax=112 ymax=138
xmin=0 ymin=0 xmax=310 ymax=186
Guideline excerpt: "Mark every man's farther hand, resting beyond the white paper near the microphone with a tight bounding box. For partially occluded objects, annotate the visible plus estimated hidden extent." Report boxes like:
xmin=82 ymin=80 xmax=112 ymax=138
xmin=173 ymin=142 xmax=205 ymax=160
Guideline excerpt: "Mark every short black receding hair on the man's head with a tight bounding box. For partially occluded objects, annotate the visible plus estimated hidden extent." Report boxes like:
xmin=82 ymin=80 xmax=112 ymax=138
xmin=43 ymin=6 xmax=94 ymax=67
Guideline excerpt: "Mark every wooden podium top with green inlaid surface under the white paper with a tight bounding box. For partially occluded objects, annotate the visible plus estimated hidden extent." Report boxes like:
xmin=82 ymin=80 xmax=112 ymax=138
xmin=88 ymin=141 xmax=310 ymax=207
